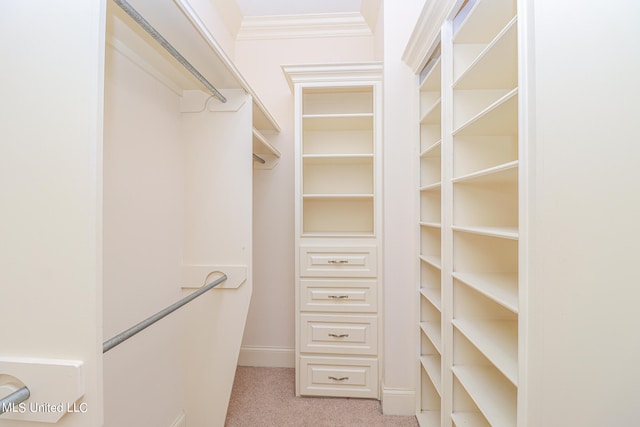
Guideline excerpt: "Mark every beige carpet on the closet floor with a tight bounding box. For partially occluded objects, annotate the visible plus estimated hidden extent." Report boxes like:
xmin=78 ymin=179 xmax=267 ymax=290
xmin=225 ymin=366 xmax=418 ymax=427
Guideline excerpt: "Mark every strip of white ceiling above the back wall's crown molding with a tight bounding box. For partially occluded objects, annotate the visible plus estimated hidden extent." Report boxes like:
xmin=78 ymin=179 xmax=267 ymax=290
xmin=236 ymin=0 xmax=362 ymax=16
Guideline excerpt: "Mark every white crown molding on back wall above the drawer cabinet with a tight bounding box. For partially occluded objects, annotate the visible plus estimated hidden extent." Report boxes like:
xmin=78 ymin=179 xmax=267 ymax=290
xmin=236 ymin=13 xmax=373 ymax=40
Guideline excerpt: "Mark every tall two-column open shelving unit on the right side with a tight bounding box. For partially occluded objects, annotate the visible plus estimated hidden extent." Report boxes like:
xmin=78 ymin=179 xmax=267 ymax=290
xmin=417 ymin=0 xmax=522 ymax=427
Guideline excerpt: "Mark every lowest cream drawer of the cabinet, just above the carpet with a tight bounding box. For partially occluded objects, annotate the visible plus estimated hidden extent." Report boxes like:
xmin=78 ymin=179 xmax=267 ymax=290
xmin=300 ymin=356 xmax=378 ymax=399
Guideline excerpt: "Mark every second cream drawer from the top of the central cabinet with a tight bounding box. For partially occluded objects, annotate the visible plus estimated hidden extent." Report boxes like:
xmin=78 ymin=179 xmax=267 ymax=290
xmin=300 ymin=279 xmax=378 ymax=312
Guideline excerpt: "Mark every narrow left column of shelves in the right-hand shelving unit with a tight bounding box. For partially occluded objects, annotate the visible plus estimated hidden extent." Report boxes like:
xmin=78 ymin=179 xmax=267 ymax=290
xmin=417 ymin=46 xmax=443 ymax=426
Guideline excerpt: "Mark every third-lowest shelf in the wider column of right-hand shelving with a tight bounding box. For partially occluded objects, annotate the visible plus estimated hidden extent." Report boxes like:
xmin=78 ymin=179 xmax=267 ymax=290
xmin=452 ymin=319 xmax=518 ymax=386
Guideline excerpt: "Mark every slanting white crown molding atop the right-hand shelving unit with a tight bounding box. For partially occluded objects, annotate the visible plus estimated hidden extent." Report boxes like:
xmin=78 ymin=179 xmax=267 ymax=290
xmin=402 ymin=0 xmax=461 ymax=74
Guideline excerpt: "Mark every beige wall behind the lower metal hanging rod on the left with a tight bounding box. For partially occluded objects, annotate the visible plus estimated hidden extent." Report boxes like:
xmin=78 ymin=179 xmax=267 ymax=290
xmin=103 ymin=46 xmax=184 ymax=427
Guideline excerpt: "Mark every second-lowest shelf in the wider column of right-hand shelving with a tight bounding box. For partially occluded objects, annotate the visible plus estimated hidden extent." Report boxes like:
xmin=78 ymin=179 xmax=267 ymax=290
xmin=452 ymin=365 xmax=517 ymax=427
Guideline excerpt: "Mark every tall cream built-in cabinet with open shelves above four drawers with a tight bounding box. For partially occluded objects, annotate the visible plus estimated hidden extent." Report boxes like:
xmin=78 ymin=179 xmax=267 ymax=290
xmin=284 ymin=64 xmax=382 ymax=398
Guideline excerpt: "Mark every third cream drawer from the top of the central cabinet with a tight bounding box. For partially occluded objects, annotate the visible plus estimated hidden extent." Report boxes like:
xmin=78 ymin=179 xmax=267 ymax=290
xmin=300 ymin=314 xmax=378 ymax=355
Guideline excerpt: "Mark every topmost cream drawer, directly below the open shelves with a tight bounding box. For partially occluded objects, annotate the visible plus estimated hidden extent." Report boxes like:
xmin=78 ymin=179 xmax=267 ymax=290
xmin=300 ymin=246 xmax=377 ymax=277
